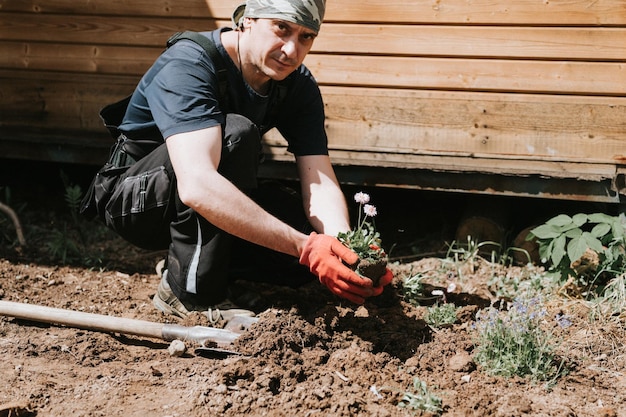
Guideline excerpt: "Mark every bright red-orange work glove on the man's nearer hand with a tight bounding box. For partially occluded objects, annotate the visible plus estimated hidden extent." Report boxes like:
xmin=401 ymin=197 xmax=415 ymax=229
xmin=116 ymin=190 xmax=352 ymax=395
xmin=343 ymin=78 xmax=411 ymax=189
xmin=300 ymin=232 xmax=372 ymax=304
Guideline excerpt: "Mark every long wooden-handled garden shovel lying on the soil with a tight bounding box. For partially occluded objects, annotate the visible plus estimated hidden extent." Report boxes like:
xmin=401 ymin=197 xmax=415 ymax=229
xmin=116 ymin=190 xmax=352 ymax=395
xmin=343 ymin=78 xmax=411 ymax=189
xmin=0 ymin=300 xmax=258 ymax=353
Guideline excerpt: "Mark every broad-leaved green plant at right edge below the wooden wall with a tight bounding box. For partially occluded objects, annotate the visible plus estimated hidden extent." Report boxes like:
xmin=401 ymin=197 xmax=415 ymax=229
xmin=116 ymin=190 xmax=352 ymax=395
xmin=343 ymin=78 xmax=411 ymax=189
xmin=527 ymin=213 xmax=626 ymax=289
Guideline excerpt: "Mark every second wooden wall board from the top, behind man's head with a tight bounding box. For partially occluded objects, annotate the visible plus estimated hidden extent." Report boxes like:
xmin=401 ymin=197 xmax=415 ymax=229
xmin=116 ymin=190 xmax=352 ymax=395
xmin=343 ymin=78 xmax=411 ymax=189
xmin=2 ymin=13 xmax=626 ymax=62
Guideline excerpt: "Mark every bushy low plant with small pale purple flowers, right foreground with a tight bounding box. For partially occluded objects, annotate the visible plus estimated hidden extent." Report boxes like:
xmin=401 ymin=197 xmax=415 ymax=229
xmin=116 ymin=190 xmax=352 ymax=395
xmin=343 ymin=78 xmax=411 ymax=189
xmin=474 ymin=298 xmax=561 ymax=381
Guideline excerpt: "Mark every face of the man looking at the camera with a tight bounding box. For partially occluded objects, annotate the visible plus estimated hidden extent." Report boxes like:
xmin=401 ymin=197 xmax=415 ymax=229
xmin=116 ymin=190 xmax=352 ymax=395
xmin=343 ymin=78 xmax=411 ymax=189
xmin=244 ymin=19 xmax=317 ymax=81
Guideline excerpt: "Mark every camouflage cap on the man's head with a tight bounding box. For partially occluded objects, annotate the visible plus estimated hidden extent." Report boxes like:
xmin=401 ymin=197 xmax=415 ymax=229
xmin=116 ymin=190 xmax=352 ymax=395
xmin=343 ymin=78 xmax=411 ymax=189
xmin=233 ymin=0 xmax=326 ymax=32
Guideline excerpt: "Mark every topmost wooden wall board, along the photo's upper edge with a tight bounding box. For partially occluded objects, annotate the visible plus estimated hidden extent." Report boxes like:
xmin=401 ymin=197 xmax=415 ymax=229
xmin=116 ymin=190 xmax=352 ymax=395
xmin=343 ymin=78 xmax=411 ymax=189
xmin=0 ymin=0 xmax=626 ymax=26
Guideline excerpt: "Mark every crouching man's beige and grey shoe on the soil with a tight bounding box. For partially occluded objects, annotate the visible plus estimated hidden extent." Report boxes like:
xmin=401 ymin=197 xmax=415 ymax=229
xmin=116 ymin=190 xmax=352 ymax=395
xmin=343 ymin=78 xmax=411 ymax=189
xmin=152 ymin=270 xmax=255 ymax=324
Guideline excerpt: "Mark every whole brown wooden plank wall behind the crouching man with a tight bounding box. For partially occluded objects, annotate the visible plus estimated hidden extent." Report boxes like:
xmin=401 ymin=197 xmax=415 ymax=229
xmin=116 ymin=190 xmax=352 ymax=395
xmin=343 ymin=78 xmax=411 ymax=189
xmin=0 ymin=0 xmax=626 ymax=202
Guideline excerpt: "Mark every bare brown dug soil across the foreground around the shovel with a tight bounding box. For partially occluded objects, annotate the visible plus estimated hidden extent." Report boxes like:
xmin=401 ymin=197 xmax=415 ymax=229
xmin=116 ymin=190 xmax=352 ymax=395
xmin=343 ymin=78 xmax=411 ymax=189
xmin=0 ymin=260 xmax=626 ymax=416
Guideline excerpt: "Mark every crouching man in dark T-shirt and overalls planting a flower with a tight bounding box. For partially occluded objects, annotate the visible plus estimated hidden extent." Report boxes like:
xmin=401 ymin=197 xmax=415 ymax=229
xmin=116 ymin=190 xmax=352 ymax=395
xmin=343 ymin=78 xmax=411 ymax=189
xmin=86 ymin=0 xmax=392 ymax=320
